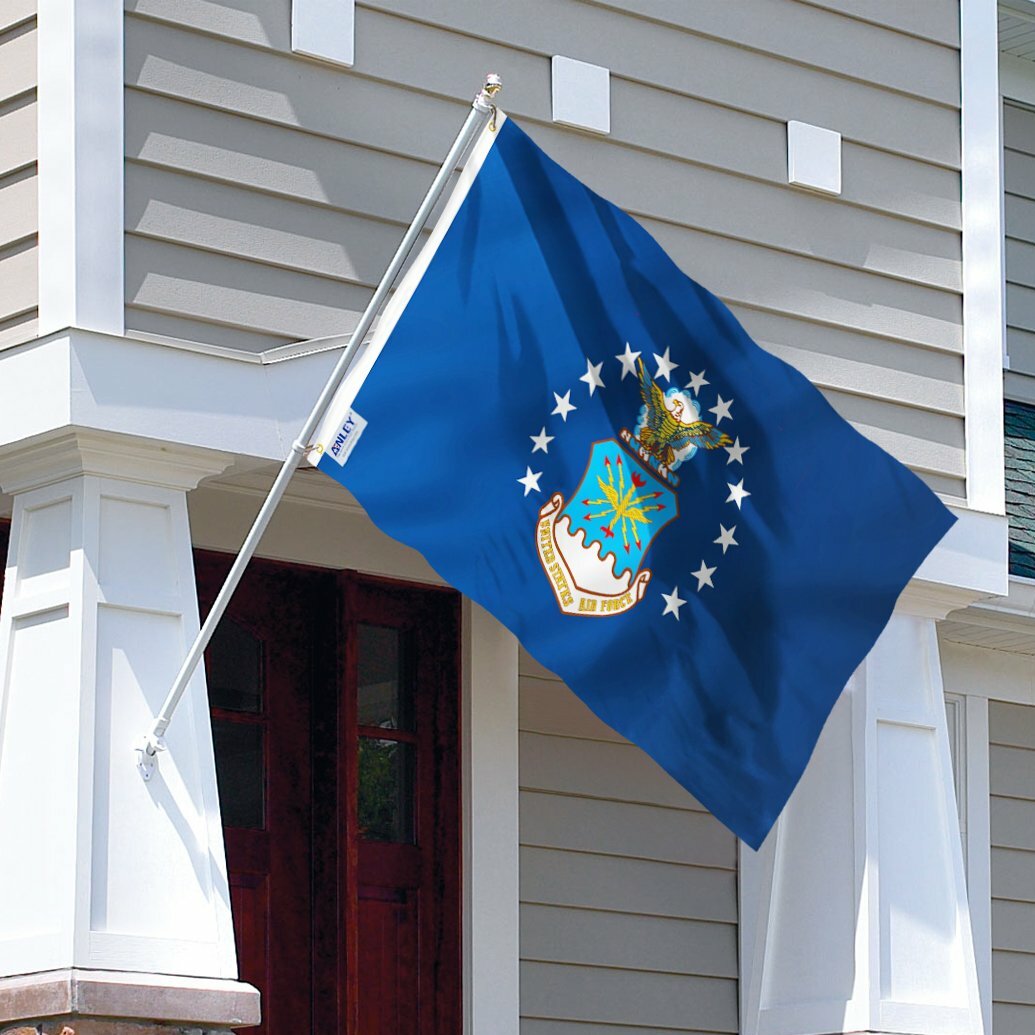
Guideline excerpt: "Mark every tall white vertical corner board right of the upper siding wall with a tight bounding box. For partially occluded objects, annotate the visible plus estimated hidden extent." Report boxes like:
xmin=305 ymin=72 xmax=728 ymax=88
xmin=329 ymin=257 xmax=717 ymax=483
xmin=959 ymin=0 xmax=1006 ymax=515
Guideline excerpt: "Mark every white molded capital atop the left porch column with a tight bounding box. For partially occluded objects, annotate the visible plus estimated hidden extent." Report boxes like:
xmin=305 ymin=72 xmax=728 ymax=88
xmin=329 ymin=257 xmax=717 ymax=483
xmin=0 ymin=428 xmax=233 ymax=494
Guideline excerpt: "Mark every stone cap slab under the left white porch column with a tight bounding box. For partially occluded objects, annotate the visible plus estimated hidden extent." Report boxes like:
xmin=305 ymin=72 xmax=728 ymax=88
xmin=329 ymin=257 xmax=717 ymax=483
xmin=0 ymin=970 xmax=260 ymax=1035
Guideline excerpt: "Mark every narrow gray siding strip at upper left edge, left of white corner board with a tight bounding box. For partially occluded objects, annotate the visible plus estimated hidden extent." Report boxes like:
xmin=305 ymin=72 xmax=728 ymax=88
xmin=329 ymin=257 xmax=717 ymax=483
xmin=0 ymin=0 xmax=39 ymax=347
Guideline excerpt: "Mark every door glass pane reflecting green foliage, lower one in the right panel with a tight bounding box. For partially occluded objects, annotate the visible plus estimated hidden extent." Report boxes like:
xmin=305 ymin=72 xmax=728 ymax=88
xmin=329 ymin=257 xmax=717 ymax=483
xmin=359 ymin=737 xmax=413 ymax=845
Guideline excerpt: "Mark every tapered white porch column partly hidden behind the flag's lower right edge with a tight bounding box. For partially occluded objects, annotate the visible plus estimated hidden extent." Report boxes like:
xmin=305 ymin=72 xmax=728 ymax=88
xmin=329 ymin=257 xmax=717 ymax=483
xmin=741 ymin=591 xmax=983 ymax=1035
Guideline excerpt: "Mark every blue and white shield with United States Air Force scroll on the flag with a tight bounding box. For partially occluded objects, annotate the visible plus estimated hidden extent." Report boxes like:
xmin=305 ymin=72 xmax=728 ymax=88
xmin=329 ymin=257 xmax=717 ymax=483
xmin=536 ymin=439 xmax=679 ymax=616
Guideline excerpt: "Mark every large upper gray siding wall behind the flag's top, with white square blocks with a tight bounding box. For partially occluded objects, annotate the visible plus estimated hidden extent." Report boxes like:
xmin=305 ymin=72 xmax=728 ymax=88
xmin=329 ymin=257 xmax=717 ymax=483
xmin=125 ymin=0 xmax=965 ymax=497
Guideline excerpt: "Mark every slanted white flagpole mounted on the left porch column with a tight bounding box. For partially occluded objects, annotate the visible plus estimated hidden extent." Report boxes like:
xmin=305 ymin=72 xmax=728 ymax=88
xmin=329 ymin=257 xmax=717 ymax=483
xmin=136 ymin=75 xmax=503 ymax=780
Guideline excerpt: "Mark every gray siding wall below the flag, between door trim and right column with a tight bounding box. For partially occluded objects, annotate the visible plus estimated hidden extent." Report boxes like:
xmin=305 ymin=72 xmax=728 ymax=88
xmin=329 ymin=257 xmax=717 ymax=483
xmin=520 ymin=653 xmax=737 ymax=1035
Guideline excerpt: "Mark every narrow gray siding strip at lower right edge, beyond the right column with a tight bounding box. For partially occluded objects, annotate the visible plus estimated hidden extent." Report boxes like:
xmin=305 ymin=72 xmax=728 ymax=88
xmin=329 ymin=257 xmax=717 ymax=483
xmin=988 ymin=701 xmax=1035 ymax=1035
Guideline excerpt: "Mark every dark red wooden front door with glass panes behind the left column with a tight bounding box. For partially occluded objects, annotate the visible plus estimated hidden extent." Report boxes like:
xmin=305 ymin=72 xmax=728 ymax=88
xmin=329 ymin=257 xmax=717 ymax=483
xmin=197 ymin=554 xmax=461 ymax=1035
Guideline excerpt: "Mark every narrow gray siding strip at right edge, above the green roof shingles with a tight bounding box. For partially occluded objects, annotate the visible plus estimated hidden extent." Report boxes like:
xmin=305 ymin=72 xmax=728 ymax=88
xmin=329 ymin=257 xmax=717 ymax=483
xmin=1003 ymin=102 xmax=1035 ymax=374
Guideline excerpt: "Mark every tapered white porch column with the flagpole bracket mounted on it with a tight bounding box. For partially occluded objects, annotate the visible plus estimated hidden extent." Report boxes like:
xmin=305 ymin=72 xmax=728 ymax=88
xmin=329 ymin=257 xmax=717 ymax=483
xmin=0 ymin=432 xmax=246 ymax=985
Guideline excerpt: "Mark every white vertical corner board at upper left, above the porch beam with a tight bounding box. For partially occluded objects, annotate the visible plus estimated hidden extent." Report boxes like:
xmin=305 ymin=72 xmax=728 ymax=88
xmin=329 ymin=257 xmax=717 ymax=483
xmin=37 ymin=0 xmax=125 ymax=335
